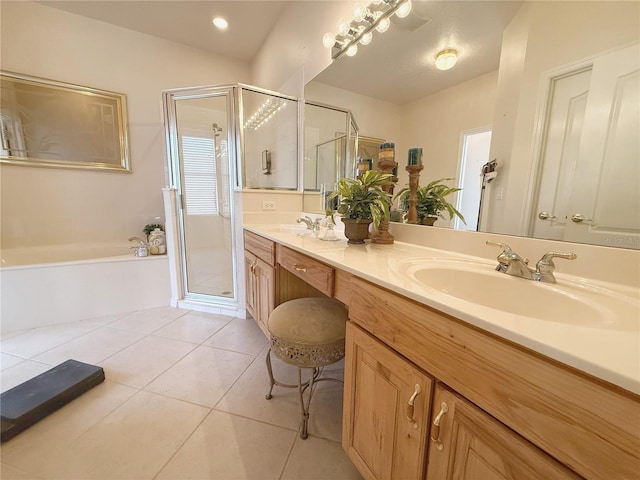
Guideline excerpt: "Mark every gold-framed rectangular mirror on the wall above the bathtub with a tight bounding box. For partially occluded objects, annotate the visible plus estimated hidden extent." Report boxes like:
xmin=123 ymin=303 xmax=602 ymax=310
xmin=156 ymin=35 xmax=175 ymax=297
xmin=0 ymin=72 xmax=131 ymax=172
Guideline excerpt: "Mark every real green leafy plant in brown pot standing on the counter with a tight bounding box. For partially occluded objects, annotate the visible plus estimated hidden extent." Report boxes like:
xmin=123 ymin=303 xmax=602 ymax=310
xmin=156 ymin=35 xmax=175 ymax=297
xmin=329 ymin=170 xmax=391 ymax=243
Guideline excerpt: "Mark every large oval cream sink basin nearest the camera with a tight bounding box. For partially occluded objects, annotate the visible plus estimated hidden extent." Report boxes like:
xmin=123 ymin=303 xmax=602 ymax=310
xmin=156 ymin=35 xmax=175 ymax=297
xmin=403 ymin=259 xmax=640 ymax=330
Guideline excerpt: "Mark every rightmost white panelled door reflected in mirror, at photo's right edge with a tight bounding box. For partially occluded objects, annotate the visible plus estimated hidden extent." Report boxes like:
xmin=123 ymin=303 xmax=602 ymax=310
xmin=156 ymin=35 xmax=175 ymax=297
xmin=565 ymin=44 xmax=640 ymax=249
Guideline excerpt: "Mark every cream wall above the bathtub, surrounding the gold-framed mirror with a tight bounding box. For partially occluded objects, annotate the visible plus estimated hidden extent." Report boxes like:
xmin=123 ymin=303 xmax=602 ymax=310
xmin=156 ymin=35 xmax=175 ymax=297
xmin=0 ymin=2 xmax=251 ymax=248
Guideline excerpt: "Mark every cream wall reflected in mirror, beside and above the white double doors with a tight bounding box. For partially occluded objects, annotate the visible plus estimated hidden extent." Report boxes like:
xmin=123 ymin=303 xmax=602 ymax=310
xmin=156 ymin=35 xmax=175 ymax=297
xmin=485 ymin=1 xmax=640 ymax=235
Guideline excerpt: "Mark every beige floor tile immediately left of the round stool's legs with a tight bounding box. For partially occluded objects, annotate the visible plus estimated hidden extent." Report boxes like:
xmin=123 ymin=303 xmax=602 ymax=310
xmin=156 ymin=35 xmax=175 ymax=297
xmin=145 ymin=346 xmax=254 ymax=407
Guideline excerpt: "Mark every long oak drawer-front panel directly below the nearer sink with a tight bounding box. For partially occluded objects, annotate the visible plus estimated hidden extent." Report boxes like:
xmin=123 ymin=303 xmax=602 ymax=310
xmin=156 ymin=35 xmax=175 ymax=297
xmin=349 ymin=278 xmax=640 ymax=480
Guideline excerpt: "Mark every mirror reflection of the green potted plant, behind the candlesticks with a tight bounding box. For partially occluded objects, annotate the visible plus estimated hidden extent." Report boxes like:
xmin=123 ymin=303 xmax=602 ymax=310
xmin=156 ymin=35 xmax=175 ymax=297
xmin=394 ymin=178 xmax=467 ymax=225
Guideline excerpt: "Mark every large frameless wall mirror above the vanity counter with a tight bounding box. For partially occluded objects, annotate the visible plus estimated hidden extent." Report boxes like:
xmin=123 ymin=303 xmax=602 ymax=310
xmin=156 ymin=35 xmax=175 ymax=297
xmin=305 ymin=0 xmax=640 ymax=249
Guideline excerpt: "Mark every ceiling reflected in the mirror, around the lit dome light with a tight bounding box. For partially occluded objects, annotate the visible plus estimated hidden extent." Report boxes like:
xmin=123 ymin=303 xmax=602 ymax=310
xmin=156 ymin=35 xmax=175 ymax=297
xmin=314 ymin=0 xmax=522 ymax=105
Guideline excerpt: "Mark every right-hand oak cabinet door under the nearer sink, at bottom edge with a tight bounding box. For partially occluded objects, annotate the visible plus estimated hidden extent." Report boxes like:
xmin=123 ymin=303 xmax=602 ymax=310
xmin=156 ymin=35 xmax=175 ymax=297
xmin=426 ymin=384 xmax=581 ymax=480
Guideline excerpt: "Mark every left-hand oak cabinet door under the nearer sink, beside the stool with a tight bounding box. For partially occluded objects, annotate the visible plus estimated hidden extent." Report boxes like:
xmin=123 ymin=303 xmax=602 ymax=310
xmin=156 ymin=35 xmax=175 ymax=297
xmin=342 ymin=322 xmax=433 ymax=480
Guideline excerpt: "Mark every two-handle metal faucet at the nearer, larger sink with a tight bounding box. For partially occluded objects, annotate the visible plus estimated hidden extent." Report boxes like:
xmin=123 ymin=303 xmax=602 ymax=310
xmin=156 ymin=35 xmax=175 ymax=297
xmin=487 ymin=240 xmax=577 ymax=283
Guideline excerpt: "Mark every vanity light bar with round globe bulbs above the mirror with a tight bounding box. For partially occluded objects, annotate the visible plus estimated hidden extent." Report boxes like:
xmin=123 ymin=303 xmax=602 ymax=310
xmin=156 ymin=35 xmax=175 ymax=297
xmin=322 ymin=0 xmax=411 ymax=60
